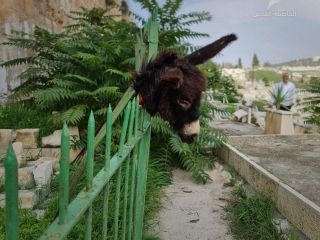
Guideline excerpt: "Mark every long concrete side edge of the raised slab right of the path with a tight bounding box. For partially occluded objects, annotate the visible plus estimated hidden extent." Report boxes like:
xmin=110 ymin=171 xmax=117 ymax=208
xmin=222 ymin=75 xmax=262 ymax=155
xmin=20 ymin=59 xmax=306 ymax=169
xmin=219 ymin=144 xmax=320 ymax=240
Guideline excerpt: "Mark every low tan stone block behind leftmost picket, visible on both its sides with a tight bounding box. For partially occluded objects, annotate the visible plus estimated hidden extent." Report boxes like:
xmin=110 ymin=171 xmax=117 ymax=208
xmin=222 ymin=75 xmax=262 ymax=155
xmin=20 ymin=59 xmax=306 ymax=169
xmin=0 ymin=190 xmax=39 ymax=209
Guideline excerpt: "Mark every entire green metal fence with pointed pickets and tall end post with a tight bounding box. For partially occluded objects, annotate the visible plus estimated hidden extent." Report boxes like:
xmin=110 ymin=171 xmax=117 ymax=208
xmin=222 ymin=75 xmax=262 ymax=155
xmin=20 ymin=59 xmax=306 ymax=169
xmin=4 ymin=10 xmax=159 ymax=240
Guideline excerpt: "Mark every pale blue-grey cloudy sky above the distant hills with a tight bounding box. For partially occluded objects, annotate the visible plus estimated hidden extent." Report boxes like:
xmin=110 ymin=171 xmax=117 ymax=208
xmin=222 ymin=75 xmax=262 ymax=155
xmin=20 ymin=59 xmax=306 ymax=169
xmin=127 ymin=0 xmax=320 ymax=66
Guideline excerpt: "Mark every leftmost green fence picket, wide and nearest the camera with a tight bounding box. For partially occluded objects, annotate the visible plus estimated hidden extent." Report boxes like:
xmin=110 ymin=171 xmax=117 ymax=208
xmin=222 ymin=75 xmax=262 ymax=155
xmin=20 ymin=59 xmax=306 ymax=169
xmin=4 ymin=144 xmax=19 ymax=240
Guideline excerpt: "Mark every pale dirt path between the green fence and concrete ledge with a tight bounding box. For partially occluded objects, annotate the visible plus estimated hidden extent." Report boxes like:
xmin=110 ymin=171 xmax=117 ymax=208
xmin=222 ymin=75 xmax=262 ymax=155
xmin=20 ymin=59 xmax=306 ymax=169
xmin=151 ymin=164 xmax=233 ymax=240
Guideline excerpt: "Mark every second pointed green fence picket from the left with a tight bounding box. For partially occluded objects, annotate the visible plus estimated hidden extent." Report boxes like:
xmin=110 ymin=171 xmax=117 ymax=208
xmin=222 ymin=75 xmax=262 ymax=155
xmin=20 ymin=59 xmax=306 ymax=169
xmin=59 ymin=124 xmax=70 ymax=224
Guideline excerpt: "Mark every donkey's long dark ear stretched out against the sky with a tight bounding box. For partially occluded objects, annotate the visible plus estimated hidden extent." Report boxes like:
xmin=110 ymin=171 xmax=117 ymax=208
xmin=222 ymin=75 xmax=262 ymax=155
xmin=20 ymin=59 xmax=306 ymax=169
xmin=185 ymin=34 xmax=238 ymax=65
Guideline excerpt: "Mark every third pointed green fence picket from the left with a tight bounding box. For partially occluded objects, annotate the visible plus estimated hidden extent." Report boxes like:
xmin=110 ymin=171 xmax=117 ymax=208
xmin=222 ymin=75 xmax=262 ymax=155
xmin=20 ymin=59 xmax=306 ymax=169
xmin=85 ymin=111 xmax=95 ymax=240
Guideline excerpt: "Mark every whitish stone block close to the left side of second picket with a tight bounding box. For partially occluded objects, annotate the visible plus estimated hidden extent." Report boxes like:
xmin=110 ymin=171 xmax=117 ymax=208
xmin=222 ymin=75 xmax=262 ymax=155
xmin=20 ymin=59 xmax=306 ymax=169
xmin=33 ymin=160 xmax=53 ymax=186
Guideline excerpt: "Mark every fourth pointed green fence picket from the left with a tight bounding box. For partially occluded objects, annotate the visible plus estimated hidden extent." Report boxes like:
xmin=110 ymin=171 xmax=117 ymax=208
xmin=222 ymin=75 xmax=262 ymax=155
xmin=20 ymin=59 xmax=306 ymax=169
xmin=102 ymin=105 xmax=112 ymax=240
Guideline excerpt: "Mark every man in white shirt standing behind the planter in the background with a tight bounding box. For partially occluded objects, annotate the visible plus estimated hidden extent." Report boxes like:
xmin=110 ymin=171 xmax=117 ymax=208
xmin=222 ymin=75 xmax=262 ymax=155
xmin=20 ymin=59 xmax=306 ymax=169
xmin=270 ymin=72 xmax=300 ymax=111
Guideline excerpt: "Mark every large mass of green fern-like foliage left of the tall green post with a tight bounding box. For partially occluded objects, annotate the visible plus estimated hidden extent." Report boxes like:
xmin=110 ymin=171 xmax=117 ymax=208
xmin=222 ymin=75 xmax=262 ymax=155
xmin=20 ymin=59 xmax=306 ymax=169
xmin=1 ymin=9 xmax=137 ymax=127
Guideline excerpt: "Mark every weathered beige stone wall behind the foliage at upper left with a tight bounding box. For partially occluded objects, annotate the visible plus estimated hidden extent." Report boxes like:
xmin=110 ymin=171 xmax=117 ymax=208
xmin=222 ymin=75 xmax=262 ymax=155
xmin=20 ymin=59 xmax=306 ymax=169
xmin=0 ymin=0 xmax=126 ymax=105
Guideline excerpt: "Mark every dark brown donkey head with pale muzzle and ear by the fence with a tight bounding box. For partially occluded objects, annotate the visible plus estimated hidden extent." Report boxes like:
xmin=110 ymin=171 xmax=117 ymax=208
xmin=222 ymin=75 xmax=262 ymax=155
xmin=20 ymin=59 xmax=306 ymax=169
xmin=134 ymin=34 xmax=237 ymax=143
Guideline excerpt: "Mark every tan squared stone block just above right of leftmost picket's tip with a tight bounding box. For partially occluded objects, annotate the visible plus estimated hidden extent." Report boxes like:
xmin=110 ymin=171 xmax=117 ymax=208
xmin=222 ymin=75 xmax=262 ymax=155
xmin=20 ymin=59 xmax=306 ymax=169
xmin=16 ymin=128 xmax=39 ymax=148
